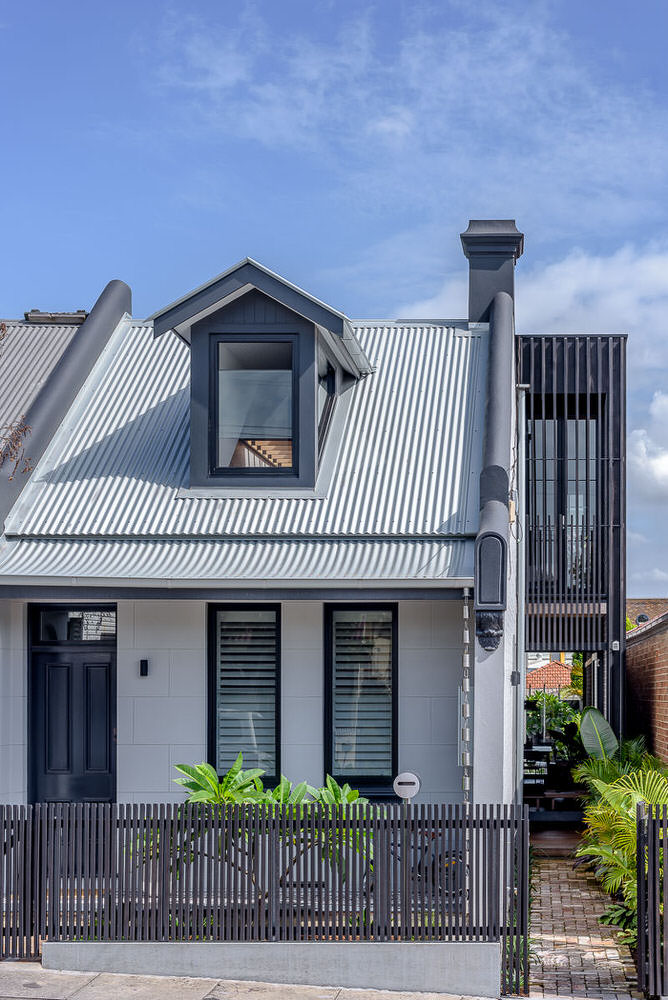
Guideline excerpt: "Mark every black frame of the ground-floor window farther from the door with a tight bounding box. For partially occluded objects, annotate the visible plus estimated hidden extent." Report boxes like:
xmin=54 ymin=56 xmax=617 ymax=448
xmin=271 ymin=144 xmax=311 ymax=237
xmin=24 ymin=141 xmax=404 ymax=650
xmin=324 ymin=601 xmax=399 ymax=797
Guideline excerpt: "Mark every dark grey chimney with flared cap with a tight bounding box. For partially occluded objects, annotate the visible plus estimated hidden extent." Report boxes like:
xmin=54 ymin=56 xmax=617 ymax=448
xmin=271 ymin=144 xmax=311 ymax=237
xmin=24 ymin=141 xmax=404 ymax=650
xmin=461 ymin=219 xmax=524 ymax=323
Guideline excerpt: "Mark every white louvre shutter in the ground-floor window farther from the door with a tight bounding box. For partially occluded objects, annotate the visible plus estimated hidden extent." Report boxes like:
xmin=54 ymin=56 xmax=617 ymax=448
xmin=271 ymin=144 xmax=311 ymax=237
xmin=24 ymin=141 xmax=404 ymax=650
xmin=331 ymin=609 xmax=394 ymax=778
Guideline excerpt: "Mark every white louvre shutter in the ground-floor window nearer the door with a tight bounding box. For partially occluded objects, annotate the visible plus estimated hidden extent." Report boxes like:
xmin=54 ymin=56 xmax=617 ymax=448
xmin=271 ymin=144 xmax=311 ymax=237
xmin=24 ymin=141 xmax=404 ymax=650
xmin=216 ymin=608 xmax=279 ymax=777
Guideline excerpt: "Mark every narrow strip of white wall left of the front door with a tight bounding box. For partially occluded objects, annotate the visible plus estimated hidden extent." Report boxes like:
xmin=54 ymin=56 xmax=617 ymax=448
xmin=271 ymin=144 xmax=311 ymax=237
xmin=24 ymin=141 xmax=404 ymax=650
xmin=0 ymin=600 xmax=28 ymax=804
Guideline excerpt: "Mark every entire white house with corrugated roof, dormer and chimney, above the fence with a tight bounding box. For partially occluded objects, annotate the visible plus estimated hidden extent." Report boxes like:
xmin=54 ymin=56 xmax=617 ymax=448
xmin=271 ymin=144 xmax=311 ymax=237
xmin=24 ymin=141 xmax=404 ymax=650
xmin=0 ymin=220 xmax=623 ymax=802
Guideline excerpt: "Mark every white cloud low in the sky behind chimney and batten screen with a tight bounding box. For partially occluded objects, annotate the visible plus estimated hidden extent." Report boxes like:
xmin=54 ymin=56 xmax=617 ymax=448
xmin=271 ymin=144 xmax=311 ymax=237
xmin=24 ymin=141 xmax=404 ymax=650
xmin=401 ymin=245 xmax=668 ymax=595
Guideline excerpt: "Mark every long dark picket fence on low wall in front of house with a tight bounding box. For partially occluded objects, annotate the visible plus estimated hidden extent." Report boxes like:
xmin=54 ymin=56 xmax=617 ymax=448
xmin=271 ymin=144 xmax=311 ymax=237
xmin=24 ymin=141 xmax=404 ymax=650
xmin=0 ymin=803 xmax=529 ymax=993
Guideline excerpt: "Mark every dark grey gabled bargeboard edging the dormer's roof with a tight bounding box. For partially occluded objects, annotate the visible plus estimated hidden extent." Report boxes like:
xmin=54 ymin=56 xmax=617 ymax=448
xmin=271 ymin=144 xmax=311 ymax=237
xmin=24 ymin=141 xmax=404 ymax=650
xmin=148 ymin=257 xmax=372 ymax=374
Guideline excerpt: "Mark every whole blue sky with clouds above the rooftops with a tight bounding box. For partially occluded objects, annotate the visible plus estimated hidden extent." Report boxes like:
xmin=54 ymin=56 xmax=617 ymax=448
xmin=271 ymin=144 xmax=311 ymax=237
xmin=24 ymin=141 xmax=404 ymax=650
xmin=0 ymin=0 xmax=668 ymax=595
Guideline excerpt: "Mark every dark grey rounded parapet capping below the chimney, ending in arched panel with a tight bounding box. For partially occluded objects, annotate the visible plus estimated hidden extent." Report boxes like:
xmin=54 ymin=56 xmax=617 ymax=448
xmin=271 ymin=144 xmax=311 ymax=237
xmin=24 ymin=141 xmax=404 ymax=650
xmin=474 ymin=292 xmax=515 ymax=611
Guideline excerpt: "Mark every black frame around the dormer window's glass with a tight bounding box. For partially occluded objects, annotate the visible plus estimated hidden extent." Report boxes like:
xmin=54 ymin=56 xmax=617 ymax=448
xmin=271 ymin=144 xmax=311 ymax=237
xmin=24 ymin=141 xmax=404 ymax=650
xmin=208 ymin=333 xmax=300 ymax=482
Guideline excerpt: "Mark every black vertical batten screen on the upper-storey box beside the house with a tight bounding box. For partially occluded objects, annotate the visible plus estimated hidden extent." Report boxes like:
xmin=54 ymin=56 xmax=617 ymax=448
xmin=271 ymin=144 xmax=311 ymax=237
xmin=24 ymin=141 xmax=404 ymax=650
xmin=518 ymin=335 xmax=626 ymax=724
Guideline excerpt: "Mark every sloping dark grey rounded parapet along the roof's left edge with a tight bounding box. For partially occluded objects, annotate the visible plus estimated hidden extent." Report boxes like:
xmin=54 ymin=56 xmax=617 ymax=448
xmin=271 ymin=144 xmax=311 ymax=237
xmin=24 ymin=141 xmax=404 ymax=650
xmin=0 ymin=279 xmax=132 ymax=523
